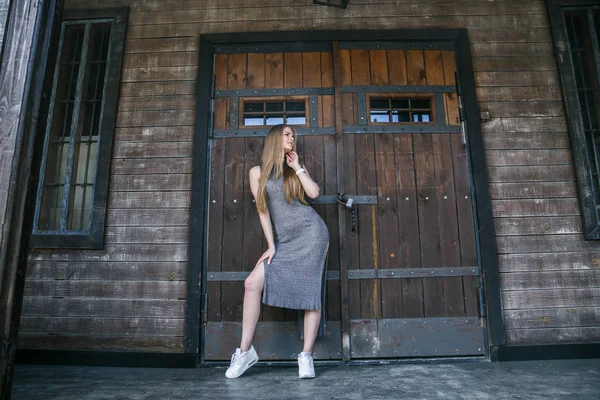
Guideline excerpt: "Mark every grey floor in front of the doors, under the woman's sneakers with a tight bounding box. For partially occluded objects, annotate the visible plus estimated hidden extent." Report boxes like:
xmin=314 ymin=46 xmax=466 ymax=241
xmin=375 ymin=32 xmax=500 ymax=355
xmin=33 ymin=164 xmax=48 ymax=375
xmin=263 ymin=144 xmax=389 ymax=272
xmin=12 ymin=359 xmax=600 ymax=400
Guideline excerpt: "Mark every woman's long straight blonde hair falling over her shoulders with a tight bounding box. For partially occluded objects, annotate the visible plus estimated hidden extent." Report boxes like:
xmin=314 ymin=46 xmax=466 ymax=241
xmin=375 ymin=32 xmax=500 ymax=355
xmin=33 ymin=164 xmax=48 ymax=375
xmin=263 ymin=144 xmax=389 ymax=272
xmin=256 ymin=124 xmax=308 ymax=212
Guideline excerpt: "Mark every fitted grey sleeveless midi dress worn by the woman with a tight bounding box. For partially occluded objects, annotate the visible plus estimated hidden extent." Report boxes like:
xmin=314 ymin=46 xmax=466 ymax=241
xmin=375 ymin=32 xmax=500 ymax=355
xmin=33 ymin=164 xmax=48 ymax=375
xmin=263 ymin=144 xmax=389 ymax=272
xmin=263 ymin=172 xmax=329 ymax=310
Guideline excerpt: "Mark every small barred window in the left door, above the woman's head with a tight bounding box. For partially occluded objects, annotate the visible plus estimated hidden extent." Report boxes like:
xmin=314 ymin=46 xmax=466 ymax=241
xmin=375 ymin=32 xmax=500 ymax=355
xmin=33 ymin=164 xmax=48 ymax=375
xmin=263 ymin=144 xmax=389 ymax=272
xmin=242 ymin=98 xmax=308 ymax=127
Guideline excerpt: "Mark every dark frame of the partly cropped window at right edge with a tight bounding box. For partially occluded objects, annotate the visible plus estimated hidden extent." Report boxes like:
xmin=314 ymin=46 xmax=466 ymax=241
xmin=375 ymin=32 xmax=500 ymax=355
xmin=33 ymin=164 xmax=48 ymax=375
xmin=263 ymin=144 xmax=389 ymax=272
xmin=547 ymin=0 xmax=600 ymax=240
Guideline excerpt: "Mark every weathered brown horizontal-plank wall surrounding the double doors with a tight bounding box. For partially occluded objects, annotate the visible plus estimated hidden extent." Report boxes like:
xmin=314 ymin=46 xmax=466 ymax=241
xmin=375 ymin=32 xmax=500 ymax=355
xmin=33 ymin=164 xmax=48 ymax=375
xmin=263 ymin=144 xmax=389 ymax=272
xmin=21 ymin=0 xmax=600 ymax=352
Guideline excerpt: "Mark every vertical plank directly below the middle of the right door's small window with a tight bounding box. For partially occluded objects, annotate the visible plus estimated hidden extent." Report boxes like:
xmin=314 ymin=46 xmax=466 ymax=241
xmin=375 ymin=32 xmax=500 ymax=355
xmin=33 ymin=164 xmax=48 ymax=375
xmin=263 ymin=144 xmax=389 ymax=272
xmin=394 ymin=135 xmax=424 ymax=318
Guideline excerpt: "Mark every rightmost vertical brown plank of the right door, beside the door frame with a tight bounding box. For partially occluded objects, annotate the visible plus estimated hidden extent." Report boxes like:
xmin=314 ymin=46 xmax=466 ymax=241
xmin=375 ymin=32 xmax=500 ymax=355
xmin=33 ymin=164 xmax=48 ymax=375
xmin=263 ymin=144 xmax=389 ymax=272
xmin=450 ymin=134 xmax=480 ymax=316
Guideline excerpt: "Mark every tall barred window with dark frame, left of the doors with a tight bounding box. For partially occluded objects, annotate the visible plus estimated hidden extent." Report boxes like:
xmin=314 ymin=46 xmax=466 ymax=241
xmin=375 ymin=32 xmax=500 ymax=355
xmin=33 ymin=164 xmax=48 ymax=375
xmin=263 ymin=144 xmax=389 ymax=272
xmin=32 ymin=10 xmax=126 ymax=248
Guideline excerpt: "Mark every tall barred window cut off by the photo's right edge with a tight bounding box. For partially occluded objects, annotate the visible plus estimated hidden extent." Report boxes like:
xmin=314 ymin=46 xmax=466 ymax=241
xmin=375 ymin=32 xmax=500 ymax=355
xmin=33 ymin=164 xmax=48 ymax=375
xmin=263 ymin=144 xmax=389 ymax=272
xmin=549 ymin=0 xmax=600 ymax=239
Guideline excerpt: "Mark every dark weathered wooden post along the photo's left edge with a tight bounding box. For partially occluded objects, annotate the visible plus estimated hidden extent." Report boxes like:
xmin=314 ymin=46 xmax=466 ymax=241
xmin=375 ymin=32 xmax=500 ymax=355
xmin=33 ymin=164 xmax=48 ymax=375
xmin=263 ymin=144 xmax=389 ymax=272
xmin=0 ymin=0 xmax=63 ymax=399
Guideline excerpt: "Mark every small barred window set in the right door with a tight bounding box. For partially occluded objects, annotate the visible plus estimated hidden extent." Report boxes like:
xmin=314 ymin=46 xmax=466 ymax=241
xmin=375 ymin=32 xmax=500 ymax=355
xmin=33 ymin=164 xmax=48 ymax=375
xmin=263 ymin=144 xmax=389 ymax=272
xmin=368 ymin=94 xmax=434 ymax=125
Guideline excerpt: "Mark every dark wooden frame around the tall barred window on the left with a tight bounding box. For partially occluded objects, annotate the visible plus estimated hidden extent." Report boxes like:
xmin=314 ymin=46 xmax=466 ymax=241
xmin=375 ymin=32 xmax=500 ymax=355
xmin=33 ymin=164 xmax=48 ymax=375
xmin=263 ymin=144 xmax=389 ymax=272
xmin=30 ymin=7 xmax=129 ymax=249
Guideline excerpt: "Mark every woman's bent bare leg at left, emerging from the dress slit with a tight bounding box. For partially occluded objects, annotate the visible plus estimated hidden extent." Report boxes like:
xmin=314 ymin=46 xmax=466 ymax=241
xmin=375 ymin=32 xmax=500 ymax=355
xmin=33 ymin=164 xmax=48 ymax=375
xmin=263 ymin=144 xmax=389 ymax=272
xmin=240 ymin=262 xmax=265 ymax=351
